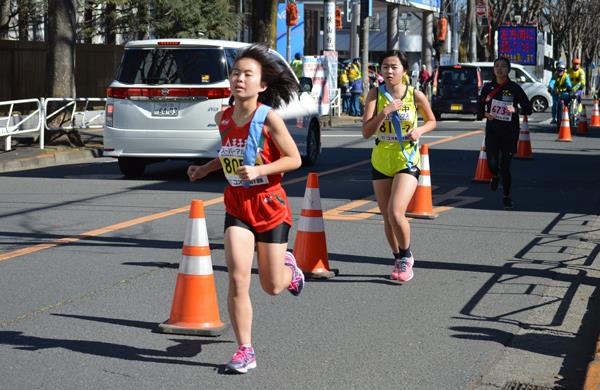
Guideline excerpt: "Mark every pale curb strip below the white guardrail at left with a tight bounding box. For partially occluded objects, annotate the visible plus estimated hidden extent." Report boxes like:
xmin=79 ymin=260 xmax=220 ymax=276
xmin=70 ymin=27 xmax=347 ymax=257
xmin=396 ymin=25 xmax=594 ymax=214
xmin=0 ymin=148 xmax=102 ymax=172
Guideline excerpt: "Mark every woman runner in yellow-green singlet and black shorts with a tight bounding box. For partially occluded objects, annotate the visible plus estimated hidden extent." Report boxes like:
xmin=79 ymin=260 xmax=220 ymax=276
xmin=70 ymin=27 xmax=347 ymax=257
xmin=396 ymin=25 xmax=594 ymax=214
xmin=362 ymin=50 xmax=436 ymax=283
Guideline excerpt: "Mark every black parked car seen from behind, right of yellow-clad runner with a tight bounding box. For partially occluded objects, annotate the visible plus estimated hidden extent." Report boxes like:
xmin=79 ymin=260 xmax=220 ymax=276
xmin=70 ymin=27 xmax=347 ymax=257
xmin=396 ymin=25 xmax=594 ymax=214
xmin=431 ymin=65 xmax=482 ymax=120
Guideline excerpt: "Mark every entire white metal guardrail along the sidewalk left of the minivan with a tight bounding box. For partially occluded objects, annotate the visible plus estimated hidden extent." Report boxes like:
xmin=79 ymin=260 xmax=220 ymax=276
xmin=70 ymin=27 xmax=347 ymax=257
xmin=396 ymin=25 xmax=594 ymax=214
xmin=0 ymin=98 xmax=106 ymax=151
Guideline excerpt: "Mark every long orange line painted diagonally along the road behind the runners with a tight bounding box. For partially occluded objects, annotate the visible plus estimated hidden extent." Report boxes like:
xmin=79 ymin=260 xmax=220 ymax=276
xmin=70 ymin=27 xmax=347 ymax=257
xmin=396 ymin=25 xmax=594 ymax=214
xmin=0 ymin=130 xmax=483 ymax=261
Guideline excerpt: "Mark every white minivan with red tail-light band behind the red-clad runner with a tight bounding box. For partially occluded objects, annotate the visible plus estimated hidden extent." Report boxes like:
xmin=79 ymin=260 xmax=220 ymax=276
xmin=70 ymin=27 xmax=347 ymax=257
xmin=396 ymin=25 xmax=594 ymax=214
xmin=103 ymin=39 xmax=321 ymax=177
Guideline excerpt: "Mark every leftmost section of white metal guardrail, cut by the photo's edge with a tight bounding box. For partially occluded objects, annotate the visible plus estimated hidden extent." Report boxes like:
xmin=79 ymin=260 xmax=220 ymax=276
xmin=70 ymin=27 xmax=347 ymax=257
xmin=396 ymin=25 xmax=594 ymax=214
xmin=0 ymin=99 xmax=44 ymax=151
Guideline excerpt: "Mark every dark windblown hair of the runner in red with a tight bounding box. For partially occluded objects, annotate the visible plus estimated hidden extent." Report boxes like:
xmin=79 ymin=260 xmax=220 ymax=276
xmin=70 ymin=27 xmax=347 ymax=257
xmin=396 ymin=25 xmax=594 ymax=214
xmin=229 ymin=43 xmax=300 ymax=108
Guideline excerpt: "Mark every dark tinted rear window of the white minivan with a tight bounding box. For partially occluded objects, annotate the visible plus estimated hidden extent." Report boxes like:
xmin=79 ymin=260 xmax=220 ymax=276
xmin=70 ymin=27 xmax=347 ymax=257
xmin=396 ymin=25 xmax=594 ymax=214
xmin=116 ymin=48 xmax=227 ymax=85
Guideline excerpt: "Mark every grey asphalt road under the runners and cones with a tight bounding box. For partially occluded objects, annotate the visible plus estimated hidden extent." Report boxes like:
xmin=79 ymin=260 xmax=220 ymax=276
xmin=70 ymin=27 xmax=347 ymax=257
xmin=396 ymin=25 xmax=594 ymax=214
xmin=0 ymin=114 xmax=600 ymax=389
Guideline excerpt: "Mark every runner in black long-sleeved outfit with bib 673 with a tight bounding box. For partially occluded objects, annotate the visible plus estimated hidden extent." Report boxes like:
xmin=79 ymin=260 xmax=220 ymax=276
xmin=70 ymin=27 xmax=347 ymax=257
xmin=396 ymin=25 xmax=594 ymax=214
xmin=477 ymin=57 xmax=533 ymax=209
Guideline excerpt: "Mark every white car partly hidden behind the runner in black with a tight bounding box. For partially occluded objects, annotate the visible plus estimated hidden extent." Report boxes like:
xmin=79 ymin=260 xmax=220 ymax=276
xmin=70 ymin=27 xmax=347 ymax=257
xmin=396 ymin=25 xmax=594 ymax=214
xmin=465 ymin=62 xmax=552 ymax=112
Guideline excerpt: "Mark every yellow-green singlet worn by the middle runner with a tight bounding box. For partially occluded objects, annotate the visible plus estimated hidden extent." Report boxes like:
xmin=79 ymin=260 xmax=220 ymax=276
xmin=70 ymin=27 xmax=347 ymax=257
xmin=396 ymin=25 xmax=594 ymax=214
xmin=371 ymin=86 xmax=421 ymax=177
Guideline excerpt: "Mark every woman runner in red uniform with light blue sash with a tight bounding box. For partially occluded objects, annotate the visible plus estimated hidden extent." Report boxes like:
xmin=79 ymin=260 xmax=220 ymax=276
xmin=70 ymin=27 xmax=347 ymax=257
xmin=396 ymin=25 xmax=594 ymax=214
xmin=188 ymin=44 xmax=304 ymax=373
